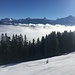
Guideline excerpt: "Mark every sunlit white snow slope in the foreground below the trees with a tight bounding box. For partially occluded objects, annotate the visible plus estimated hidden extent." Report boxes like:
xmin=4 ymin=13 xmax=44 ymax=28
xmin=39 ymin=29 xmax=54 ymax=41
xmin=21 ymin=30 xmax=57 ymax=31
xmin=0 ymin=53 xmax=75 ymax=75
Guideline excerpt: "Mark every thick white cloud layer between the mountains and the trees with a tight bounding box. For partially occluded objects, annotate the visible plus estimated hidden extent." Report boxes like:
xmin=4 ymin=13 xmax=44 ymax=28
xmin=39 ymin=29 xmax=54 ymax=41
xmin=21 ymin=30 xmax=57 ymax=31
xmin=0 ymin=24 xmax=75 ymax=40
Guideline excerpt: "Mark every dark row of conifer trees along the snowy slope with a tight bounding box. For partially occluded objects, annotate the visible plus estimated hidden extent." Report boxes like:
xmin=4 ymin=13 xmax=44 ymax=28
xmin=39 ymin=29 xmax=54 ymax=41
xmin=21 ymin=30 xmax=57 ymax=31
xmin=0 ymin=31 xmax=75 ymax=65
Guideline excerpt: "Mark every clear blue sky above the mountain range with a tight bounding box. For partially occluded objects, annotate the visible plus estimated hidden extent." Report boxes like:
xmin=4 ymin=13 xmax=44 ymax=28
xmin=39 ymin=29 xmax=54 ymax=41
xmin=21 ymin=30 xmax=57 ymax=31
xmin=0 ymin=0 xmax=75 ymax=20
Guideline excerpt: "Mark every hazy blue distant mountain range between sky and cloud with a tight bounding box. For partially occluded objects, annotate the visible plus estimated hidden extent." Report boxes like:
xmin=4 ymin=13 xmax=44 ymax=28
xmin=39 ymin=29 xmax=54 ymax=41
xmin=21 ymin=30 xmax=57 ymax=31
xmin=0 ymin=15 xmax=75 ymax=25
